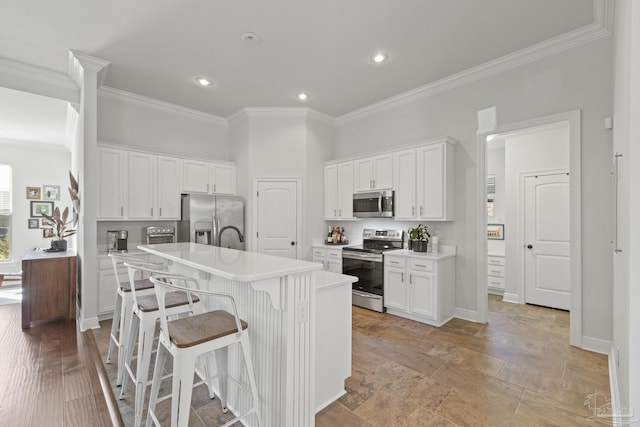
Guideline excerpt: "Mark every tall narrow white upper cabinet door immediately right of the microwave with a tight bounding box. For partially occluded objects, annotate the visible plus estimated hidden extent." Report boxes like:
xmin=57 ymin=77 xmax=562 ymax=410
xmin=393 ymin=149 xmax=417 ymax=220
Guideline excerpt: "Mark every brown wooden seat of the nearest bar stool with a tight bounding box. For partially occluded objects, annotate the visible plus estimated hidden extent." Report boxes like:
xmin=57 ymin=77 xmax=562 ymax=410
xmin=167 ymin=312 xmax=248 ymax=348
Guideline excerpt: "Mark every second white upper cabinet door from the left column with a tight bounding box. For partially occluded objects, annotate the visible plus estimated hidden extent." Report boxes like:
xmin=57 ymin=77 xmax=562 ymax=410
xmin=127 ymin=152 xmax=156 ymax=220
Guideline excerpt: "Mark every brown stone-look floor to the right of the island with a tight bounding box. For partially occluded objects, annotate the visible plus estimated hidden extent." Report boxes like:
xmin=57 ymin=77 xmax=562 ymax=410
xmin=316 ymin=295 xmax=609 ymax=427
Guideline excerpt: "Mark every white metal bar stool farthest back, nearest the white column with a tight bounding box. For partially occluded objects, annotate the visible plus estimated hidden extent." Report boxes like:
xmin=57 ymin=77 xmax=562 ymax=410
xmin=105 ymin=254 xmax=164 ymax=386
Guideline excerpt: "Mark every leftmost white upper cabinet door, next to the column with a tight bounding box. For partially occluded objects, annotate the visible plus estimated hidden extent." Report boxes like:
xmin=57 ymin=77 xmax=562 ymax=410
xmin=98 ymin=147 xmax=127 ymax=219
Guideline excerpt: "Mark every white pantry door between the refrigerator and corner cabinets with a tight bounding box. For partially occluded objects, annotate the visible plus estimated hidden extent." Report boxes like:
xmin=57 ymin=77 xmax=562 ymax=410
xmin=257 ymin=181 xmax=298 ymax=258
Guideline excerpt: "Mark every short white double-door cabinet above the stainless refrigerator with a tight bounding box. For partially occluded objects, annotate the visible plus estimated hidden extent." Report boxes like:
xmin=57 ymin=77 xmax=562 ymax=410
xmin=182 ymin=159 xmax=236 ymax=194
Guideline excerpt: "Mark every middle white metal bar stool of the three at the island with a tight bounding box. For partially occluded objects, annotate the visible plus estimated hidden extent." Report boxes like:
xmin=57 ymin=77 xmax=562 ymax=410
xmin=120 ymin=261 xmax=201 ymax=427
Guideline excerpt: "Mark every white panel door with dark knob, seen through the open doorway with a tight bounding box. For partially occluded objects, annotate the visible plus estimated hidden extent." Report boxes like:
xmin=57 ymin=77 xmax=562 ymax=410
xmin=524 ymin=173 xmax=571 ymax=310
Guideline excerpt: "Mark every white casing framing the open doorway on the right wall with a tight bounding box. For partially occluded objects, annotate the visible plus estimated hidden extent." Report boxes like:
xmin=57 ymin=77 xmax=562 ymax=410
xmin=476 ymin=110 xmax=582 ymax=347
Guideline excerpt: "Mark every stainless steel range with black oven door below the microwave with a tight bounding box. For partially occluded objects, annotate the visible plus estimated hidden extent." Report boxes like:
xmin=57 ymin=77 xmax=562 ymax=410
xmin=342 ymin=228 xmax=404 ymax=313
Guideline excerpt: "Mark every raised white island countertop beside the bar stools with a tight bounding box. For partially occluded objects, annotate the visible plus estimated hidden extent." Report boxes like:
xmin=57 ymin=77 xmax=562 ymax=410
xmin=138 ymin=242 xmax=322 ymax=282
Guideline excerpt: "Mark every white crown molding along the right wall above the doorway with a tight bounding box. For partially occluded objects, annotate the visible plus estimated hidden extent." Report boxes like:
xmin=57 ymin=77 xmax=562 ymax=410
xmin=335 ymin=0 xmax=613 ymax=126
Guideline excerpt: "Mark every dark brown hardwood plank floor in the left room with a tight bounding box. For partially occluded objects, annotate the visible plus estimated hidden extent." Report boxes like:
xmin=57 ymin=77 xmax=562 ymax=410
xmin=0 ymin=304 xmax=121 ymax=427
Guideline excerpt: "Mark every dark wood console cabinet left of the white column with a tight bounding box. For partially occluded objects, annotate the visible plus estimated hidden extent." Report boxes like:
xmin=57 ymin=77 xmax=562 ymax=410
xmin=22 ymin=249 xmax=77 ymax=329
